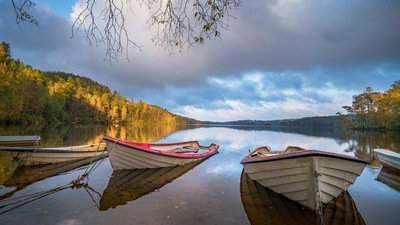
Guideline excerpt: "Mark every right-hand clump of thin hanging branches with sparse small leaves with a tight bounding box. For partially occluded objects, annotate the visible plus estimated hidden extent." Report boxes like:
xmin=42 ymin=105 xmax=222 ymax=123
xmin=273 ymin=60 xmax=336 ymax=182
xmin=148 ymin=0 xmax=241 ymax=53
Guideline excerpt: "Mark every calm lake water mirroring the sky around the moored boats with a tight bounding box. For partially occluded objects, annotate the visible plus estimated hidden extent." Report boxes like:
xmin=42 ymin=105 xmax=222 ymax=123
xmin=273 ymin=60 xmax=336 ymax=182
xmin=0 ymin=127 xmax=400 ymax=225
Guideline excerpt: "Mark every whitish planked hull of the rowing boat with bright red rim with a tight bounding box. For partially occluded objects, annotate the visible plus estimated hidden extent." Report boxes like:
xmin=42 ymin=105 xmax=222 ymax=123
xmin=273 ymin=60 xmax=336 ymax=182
xmin=104 ymin=136 xmax=217 ymax=170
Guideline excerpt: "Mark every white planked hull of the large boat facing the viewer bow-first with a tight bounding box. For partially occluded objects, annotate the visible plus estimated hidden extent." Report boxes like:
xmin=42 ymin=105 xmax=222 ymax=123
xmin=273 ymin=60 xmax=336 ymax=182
xmin=242 ymin=147 xmax=367 ymax=211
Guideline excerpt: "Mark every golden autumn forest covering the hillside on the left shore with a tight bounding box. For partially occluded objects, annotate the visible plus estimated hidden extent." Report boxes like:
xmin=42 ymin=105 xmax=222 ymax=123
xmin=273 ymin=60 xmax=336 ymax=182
xmin=0 ymin=42 xmax=198 ymax=125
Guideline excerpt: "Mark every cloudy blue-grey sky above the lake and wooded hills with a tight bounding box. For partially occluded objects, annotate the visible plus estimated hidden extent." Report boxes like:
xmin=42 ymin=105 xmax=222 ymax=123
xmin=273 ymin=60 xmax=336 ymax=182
xmin=0 ymin=0 xmax=400 ymax=122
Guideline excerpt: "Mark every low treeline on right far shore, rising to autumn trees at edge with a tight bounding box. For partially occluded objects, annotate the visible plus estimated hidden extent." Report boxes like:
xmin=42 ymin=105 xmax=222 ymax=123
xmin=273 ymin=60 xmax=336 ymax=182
xmin=203 ymin=80 xmax=400 ymax=131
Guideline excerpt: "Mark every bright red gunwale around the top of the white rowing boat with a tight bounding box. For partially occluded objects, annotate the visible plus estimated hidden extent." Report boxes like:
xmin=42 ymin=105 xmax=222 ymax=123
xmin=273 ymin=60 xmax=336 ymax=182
xmin=103 ymin=137 xmax=219 ymax=159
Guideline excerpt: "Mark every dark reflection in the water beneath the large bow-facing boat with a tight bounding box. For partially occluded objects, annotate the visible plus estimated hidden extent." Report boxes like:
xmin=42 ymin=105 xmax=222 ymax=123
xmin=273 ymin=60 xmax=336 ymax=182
xmin=240 ymin=171 xmax=365 ymax=225
